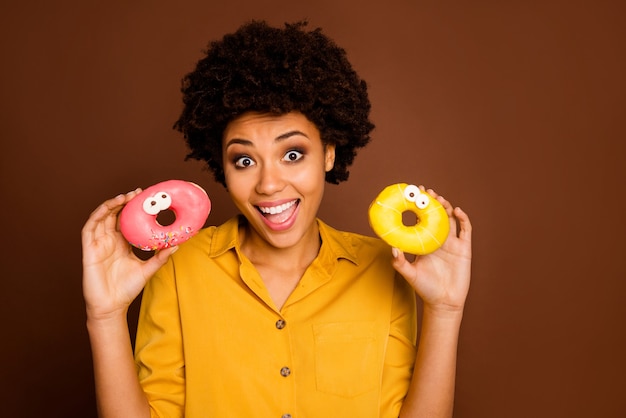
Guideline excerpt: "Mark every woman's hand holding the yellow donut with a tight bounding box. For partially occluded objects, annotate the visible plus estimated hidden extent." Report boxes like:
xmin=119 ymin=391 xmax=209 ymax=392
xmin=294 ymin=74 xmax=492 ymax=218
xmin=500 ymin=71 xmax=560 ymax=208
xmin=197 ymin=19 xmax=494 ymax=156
xmin=393 ymin=186 xmax=472 ymax=312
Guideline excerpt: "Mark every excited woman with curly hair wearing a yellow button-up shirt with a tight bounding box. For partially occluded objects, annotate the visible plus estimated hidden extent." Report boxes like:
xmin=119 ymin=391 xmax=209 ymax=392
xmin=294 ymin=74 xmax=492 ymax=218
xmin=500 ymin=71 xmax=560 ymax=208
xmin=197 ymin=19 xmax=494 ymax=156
xmin=82 ymin=22 xmax=471 ymax=418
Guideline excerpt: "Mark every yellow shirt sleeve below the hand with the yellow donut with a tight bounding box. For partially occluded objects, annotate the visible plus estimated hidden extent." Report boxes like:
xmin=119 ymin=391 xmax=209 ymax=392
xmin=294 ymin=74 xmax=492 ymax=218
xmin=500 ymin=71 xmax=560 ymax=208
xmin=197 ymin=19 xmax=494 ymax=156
xmin=380 ymin=274 xmax=417 ymax=418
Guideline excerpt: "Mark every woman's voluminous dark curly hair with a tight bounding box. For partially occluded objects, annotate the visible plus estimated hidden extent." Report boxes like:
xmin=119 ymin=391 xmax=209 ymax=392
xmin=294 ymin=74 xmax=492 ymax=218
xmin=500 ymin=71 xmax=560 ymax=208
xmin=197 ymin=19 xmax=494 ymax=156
xmin=174 ymin=21 xmax=374 ymax=186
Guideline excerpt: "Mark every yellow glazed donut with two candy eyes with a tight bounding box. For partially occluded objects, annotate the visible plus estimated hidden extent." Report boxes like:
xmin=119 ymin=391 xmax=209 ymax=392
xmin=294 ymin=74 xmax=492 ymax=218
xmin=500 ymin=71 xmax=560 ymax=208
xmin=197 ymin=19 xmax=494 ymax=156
xmin=369 ymin=183 xmax=450 ymax=255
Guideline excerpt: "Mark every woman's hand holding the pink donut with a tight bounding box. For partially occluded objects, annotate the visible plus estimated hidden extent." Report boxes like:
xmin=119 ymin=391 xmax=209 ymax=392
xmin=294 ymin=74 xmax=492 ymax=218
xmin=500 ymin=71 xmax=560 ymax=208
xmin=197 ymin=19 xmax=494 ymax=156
xmin=82 ymin=189 xmax=177 ymax=319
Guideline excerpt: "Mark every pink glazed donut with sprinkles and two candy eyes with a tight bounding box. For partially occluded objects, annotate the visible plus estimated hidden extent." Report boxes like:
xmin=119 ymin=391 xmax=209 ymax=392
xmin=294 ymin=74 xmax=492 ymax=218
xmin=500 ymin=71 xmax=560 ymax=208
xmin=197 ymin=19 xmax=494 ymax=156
xmin=120 ymin=180 xmax=211 ymax=251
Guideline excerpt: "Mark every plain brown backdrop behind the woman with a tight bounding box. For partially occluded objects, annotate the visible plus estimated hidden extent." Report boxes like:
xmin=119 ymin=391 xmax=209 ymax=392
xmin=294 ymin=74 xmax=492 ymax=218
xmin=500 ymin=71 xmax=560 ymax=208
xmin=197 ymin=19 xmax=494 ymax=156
xmin=0 ymin=0 xmax=626 ymax=418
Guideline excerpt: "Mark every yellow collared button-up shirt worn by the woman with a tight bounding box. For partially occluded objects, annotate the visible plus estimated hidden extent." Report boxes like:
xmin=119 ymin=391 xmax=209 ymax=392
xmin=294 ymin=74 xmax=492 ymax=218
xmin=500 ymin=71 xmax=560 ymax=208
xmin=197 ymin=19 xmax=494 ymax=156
xmin=135 ymin=218 xmax=417 ymax=418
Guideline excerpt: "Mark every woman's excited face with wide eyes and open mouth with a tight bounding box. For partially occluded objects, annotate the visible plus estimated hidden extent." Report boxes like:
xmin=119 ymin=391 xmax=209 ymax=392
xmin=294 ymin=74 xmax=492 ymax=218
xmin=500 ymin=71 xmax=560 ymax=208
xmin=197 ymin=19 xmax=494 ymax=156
xmin=223 ymin=112 xmax=335 ymax=248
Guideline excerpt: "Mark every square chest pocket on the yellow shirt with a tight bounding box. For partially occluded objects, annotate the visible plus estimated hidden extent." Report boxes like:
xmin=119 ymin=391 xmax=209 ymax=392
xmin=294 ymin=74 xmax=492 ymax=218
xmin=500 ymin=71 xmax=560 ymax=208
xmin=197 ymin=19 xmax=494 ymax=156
xmin=313 ymin=322 xmax=382 ymax=397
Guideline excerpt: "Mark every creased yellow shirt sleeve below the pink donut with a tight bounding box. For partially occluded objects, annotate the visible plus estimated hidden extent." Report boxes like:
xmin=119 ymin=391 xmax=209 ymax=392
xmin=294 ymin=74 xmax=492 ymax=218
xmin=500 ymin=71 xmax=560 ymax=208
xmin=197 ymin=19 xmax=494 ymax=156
xmin=135 ymin=259 xmax=185 ymax=418
